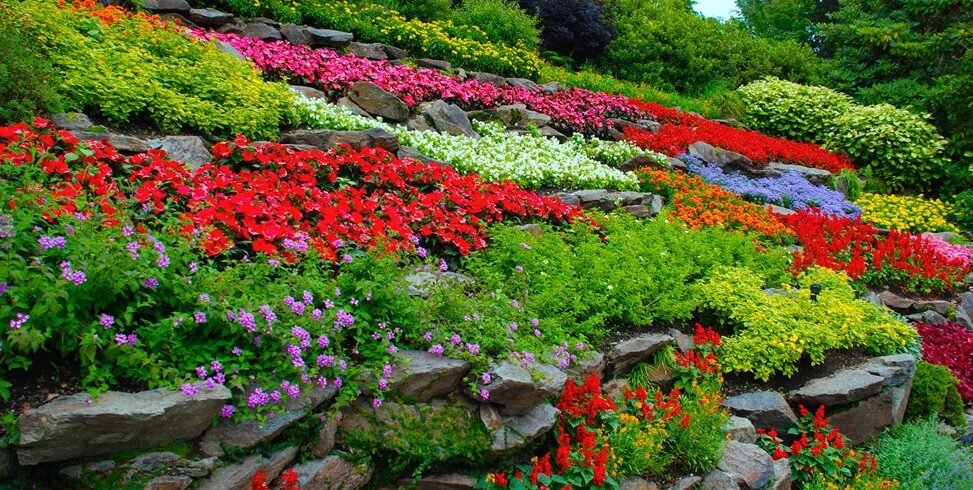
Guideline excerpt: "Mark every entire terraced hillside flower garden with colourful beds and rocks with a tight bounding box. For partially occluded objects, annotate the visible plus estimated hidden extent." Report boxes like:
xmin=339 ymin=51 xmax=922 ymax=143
xmin=0 ymin=0 xmax=973 ymax=489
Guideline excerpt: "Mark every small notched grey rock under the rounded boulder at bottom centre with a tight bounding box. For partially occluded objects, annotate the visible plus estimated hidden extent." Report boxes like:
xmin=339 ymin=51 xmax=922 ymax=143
xmin=480 ymin=403 xmax=560 ymax=456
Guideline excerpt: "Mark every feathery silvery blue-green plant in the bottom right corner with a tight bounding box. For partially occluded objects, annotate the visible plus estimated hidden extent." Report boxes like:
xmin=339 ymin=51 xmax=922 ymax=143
xmin=872 ymin=419 xmax=973 ymax=490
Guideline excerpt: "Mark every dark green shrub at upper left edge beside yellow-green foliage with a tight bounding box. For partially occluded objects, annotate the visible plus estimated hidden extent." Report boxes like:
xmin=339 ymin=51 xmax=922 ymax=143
xmin=0 ymin=19 xmax=61 ymax=123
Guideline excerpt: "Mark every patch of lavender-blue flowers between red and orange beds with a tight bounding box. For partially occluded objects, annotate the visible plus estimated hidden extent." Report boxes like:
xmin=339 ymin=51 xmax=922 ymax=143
xmin=679 ymin=154 xmax=861 ymax=217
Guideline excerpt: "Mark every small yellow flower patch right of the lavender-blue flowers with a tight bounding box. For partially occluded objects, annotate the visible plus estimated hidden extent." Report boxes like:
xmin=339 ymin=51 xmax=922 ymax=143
xmin=855 ymin=193 xmax=959 ymax=232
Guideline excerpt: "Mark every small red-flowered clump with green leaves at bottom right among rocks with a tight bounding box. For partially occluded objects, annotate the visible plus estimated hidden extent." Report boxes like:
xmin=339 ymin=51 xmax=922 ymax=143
xmin=757 ymin=405 xmax=898 ymax=490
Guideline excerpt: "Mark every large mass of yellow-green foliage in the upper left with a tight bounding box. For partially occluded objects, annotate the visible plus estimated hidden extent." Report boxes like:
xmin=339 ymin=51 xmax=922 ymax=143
xmin=4 ymin=0 xmax=292 ymax=138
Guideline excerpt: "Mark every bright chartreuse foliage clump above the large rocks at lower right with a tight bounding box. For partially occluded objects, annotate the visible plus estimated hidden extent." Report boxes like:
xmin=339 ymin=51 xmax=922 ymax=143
xmin=702 ymin=268 xmax=916 ymax=380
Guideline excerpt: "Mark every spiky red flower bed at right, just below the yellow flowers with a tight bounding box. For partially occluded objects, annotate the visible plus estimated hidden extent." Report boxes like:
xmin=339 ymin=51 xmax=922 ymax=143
xmin=778 ymin=210 xmax=970 ymax=291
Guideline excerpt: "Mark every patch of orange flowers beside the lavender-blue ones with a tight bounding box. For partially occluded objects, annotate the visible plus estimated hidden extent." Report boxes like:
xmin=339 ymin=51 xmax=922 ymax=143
xmin=637 ymin=169 xmax=791 ymax=238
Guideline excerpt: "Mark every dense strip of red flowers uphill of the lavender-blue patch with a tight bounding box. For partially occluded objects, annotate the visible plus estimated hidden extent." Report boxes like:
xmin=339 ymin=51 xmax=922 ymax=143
xmin=624 ymin=100 xmax=854 ymax=172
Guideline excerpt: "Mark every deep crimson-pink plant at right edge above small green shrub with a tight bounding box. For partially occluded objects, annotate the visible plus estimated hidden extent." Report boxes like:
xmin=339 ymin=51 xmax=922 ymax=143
xmin=916 ymin=323 xmax=973 ymax=402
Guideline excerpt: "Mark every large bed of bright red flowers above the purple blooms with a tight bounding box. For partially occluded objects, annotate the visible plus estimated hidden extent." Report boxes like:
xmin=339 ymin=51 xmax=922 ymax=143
xmin=0 ymin=119 xmax=581 ymax=259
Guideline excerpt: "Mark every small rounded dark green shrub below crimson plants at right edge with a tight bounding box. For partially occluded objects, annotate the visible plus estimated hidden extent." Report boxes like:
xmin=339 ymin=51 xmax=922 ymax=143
xmin=905 ymin=361 xmax=966 ymax=428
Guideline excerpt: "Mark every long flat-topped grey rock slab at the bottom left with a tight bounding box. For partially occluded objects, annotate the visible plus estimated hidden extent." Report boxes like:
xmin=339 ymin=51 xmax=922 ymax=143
xmin=17 ymin=386 xmax=230 ymax=466
